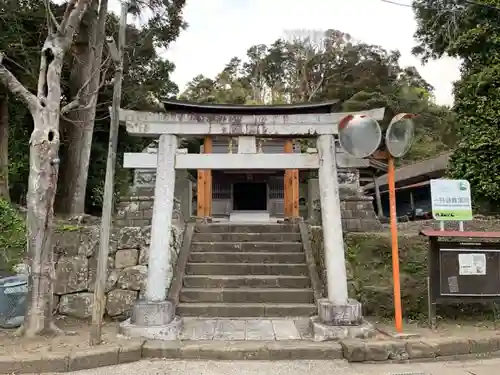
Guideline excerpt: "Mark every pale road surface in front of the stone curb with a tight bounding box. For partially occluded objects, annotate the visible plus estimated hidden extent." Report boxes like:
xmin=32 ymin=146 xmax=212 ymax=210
xmin=32 ymin=359 xmax=500 ymax=375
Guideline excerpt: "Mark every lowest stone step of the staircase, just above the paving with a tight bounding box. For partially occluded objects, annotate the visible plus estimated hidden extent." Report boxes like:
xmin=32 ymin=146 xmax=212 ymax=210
xmin=176 ymin=302 xmax=317 ymax=318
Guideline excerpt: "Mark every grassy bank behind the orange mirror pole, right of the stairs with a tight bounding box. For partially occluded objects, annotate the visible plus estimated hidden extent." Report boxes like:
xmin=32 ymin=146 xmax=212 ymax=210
xmin=309 ymin=226 xmax=496 ymax=319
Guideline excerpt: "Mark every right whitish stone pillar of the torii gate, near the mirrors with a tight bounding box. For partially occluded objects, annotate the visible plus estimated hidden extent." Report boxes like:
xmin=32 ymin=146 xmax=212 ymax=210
xmin=317 ymin=135 xmax=348 ymax=305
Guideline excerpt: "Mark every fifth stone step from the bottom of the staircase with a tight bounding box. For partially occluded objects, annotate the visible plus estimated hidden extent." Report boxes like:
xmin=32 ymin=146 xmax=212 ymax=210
xmin=189 ymin=251 xmax=306 ymax=263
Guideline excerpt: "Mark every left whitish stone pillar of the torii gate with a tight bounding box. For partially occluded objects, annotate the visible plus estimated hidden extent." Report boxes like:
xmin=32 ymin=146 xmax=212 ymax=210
xmin=145 ymin=134 xmax=177 ymax=302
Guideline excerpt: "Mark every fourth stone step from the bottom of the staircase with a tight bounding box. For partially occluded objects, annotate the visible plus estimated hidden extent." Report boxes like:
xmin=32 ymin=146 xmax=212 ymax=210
xmin=186 ymin=263 xmax=309 ymax=276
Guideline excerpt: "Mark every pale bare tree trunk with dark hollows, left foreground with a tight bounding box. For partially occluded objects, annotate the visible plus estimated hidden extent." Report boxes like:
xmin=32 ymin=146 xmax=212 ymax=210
xmin=23 ymin=37 xmax=64 ymax=337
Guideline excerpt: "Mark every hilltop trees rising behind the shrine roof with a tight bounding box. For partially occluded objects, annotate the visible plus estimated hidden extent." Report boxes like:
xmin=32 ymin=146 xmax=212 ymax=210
xmin=181 ymin=30 xmax=455 ymax=160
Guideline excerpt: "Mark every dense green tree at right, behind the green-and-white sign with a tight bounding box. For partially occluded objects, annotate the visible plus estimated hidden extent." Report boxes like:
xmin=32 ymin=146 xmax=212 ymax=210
xmin=414 ymin=0 xmax=500 ymax=206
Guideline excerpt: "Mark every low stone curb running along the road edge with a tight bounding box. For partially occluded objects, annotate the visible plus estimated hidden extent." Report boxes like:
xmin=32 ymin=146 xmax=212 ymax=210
xmin=0 ymin=335 xmax=500 ymax=374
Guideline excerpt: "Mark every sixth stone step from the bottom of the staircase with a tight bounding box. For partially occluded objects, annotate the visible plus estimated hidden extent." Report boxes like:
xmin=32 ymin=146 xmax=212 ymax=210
xmin=191 ymin=242 xmax=303 ymax=253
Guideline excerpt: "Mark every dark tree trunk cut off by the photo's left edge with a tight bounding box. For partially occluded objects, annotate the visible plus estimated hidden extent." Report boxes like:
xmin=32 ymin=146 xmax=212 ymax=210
xmin=0 ymin=89 xmax=10 ymax=201
